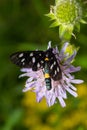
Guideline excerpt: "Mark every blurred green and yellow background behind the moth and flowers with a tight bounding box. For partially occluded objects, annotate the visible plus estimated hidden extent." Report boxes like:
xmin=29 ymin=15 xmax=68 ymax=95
xmin=0 ymin=0 xmax=87 ymax=130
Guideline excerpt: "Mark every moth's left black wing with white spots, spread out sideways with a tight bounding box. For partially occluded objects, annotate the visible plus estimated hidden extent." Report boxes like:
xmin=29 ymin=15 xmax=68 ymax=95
xmin=10 ymin=51 xmax=44 ymax=71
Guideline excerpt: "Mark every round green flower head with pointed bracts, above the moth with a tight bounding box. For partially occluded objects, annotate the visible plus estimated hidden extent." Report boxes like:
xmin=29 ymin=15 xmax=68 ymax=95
xmin=47 ymin=0 xmax=85 ymax=41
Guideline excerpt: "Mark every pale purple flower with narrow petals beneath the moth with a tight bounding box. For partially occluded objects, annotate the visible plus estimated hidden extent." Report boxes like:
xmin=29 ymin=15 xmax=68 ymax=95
xmin=19 ymin=42 xmax=83 ymax=107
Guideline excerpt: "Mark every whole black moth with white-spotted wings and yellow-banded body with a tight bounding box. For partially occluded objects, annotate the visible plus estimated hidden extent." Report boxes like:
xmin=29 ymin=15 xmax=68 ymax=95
xmin=10 ymin=48 xmax=62 ymax=90
